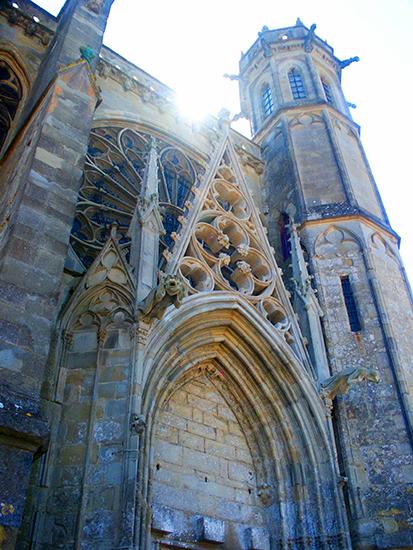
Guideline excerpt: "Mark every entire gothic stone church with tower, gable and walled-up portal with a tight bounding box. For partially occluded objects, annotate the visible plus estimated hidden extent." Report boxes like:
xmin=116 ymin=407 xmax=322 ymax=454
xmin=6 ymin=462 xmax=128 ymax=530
xmin=0 ymin=0 xmax=413 ymax=550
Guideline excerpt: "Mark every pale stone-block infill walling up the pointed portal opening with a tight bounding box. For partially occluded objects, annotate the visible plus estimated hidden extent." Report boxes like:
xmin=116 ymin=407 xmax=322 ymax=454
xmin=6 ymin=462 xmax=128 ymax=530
xmin=152 ymin=376 xmax=268 ymax=548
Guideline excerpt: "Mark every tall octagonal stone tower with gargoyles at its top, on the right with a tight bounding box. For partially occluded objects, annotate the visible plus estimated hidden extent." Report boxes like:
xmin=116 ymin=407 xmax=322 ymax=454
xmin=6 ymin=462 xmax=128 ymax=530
xmin=236 ymin=19 xmax=413 ymax=549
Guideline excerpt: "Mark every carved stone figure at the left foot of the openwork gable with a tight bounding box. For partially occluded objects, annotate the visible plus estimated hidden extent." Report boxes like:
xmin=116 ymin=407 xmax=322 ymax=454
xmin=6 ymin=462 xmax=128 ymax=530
xmin=137 ymin=272 xmax=186 ymax=319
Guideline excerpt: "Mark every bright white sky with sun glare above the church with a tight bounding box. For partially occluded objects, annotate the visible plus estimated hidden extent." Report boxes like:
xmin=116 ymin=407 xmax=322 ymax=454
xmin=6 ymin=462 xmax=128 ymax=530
xmin=37 ymin=0 xmax=413 ymax=283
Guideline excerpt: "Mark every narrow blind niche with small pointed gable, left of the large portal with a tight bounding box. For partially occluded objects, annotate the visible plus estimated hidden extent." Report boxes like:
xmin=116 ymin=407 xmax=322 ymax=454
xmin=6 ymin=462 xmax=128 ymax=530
xmin=22 ymin=243 xmax=134 ymax=550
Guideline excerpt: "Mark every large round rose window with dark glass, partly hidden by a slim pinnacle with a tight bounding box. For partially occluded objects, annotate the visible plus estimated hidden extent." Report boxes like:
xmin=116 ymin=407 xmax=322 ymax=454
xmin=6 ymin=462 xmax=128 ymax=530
xmin=71 ymin=127 xmax=201 ymax=267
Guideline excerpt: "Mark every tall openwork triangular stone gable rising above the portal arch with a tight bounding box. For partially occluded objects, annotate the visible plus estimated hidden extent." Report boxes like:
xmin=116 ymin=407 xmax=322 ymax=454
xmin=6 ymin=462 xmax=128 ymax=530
xmin=163 ymin=136 xmax=308 ymax=361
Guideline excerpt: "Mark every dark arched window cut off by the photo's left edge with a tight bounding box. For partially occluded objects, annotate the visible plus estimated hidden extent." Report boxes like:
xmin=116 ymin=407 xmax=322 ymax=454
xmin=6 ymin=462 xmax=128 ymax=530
xmin=0 ymin=59 xmax=22 ymax=149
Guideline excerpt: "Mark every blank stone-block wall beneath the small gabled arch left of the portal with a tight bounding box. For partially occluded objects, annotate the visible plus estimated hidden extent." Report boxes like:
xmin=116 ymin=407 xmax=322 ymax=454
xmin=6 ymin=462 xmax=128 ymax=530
xmin=18 ymin=327 xmax=131 ymax=550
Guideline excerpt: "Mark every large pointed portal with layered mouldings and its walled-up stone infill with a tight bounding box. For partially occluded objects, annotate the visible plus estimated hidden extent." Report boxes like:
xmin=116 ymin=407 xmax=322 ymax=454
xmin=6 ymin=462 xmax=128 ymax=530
xmin=136 ymin=292 xmax=348 ymax=549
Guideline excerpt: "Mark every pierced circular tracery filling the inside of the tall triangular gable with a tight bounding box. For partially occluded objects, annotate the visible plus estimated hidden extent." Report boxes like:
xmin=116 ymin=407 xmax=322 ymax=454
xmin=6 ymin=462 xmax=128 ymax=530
xmin=179 ymin=149 xmax=292 ymax=342
